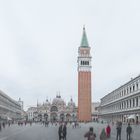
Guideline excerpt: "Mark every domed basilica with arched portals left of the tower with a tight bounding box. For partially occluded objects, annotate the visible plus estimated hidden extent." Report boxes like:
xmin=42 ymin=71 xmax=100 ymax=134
xmin=27 ymin=95 xmax=77 ymax=122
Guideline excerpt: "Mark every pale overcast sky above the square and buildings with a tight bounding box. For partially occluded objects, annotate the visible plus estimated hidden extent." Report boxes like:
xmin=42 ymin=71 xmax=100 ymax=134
xmin=0 ymin=0 xmax=140 ymax=109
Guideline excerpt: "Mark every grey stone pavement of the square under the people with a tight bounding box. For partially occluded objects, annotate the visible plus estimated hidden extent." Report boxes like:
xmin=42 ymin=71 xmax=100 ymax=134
xmin=0 ymin=123 xmax=140 ymax=140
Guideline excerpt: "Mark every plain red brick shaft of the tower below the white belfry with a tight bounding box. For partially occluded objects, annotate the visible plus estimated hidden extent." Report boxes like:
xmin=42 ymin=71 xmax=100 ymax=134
xmin=78 ymin=72 xmax=91 ymax=121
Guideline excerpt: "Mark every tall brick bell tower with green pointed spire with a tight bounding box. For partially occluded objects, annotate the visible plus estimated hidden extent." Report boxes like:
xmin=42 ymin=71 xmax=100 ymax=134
xmin=78 ymin=27 xmax=91 ymax=121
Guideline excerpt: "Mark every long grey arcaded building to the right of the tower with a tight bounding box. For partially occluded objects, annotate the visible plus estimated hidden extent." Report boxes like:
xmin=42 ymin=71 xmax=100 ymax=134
xmin=100 ymin=75 xmax=140 ymax=123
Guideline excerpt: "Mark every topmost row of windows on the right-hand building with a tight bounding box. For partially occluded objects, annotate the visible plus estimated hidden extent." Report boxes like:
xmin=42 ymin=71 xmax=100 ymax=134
xmin=102 ymin=77 xmax=140 ymax=104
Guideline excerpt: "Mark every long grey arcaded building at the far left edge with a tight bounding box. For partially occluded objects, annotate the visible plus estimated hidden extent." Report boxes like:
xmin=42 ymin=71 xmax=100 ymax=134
xmin=0 ymin=91 xmax=21 ymax=121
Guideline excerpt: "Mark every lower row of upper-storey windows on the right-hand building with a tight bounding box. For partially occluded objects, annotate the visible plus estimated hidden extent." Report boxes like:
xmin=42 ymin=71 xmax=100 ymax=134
xmin=101 ymin=96 xmax=140 ymax=112
